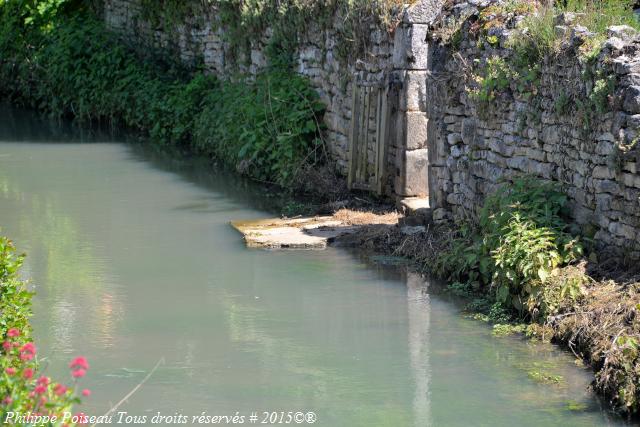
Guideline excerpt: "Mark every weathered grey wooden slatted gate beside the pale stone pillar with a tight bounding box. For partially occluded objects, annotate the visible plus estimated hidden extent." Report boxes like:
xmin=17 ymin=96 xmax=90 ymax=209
xmin=348 ymin=82 xmax=389 ymax=194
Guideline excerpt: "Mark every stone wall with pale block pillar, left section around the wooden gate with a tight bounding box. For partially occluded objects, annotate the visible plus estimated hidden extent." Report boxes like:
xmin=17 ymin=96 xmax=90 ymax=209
xmin=104 ymin=0 xmax=444 ymax=196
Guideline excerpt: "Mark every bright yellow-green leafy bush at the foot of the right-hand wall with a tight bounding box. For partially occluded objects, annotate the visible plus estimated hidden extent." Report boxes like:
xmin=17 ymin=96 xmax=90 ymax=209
xmin=437 ymin=178 xmax=582 ymax=315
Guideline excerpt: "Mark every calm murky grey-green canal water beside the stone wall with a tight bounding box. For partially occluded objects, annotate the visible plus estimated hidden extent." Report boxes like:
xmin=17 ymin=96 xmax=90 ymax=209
xmin=0 ymin=109 xmax=620 ymax=426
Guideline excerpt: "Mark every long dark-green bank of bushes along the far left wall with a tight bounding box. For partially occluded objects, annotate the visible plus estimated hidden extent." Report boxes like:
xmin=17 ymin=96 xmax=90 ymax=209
xmin=0 ymin=0 xmax=323 ymax=187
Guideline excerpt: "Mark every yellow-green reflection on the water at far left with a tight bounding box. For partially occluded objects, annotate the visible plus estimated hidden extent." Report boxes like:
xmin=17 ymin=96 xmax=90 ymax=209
xmin=0 ymin=150 xmax=122 ymax=354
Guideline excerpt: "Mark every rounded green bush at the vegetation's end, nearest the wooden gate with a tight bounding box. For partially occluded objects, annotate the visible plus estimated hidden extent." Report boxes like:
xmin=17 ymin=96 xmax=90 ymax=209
xmin=194 ymin=69 xmax=323 ymax=185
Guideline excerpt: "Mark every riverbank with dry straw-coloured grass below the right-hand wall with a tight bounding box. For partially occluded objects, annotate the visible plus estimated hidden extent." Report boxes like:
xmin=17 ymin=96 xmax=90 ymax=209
xmin=334 ymin=206 xmax=640 ymax=413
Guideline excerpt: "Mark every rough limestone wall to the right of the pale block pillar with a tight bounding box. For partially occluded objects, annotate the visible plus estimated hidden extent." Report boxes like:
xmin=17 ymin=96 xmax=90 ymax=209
xmin=424 ymin=1 xmax=640 ymax=259
